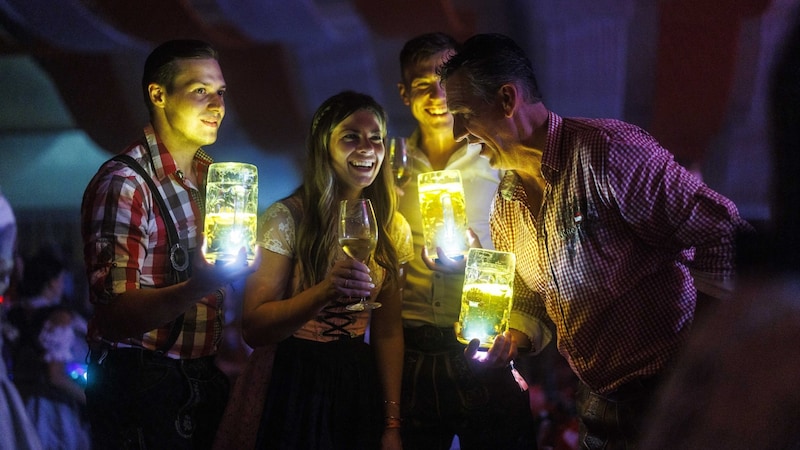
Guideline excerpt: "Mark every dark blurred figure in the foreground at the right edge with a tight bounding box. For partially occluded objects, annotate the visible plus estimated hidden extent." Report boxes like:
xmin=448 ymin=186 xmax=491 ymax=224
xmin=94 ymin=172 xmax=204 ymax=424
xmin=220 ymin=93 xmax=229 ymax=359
xmin=642 ymin=4 xmax=800 ymax=450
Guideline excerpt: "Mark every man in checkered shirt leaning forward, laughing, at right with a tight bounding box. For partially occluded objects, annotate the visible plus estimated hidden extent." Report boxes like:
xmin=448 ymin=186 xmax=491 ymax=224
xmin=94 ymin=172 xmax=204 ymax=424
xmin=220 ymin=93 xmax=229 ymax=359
xmin=441 ymin=34 xmax=751 ymax=449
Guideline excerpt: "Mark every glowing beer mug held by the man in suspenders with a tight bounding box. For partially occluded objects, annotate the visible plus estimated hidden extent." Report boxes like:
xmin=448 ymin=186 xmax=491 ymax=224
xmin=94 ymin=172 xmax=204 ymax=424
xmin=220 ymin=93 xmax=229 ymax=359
xmin=203 ymin=162 xmax=258 ymax=264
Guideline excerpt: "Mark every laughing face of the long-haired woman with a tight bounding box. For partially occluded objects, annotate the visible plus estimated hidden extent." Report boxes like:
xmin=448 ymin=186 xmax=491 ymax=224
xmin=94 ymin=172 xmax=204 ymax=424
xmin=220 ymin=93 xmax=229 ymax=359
xmin=328 ymin=109 xmax=386 ymax=198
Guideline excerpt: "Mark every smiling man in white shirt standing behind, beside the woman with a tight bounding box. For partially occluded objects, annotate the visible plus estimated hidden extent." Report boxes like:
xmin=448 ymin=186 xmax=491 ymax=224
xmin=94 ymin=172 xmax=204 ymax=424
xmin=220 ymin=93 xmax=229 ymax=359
xmin=397 ymin=32 xmax=535 ymax=449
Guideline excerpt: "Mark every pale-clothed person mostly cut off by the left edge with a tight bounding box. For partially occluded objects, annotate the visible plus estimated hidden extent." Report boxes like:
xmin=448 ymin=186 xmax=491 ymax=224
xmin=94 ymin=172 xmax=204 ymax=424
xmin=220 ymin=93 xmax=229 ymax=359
xmin=0 ymin=192 xmax=42 ymax=450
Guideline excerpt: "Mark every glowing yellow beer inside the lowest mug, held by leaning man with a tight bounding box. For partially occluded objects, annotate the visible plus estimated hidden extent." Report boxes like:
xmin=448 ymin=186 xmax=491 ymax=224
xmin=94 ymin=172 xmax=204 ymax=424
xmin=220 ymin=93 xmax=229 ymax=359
xmin=456 ymin=283 xmax=513 ymax=348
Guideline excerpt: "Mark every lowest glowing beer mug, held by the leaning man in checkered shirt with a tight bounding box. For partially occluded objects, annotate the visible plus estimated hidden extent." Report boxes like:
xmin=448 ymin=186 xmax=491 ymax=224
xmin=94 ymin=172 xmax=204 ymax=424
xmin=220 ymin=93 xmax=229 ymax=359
xmin=455 ymin=248 xmax=516 ymax=348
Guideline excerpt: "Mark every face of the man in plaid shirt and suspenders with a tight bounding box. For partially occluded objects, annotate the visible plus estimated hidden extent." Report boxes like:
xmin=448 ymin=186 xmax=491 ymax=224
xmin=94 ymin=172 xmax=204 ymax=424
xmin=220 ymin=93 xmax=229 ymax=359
xmin=149 ymin=58 xmax=226 ymax=151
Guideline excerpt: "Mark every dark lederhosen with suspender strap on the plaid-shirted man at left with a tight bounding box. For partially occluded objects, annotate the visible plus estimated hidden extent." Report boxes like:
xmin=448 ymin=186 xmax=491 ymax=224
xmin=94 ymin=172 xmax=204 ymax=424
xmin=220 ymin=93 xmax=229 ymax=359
xmin=86 ymin=155 xmax=229 ymax=449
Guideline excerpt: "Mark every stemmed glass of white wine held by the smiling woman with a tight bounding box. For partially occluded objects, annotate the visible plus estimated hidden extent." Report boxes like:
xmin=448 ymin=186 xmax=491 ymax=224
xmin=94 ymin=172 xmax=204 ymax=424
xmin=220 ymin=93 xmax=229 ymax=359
xmin=339 ymin=198 xmax=381 ymax=311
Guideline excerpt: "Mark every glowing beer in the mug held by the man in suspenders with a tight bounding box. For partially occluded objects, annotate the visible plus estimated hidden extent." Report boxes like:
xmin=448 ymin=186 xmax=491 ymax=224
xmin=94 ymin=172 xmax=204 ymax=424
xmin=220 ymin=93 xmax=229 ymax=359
xmin=205 ymin=212 xmax=257 ymax=264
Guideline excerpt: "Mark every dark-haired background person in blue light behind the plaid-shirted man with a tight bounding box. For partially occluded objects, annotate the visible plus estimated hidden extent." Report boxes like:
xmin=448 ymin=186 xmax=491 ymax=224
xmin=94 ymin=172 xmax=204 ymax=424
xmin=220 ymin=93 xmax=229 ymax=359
xmin=8 ymin=245 xmax=91 ymax=449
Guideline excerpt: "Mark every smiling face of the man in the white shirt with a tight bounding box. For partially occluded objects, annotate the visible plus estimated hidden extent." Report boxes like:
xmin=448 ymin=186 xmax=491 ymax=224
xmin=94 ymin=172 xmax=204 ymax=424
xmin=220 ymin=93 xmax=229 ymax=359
xmin=398 ymin=50 xmax=453 ymax=133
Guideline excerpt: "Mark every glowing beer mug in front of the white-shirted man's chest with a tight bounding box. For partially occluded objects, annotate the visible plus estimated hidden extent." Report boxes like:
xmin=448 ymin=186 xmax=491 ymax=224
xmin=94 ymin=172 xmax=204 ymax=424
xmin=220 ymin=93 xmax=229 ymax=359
xmin=417 ymin=170 xmax=469 ymax=258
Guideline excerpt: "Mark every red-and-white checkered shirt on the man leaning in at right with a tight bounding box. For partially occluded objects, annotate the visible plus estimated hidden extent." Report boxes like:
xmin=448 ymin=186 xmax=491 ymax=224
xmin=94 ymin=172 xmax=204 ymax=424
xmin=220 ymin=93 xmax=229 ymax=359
xmin=490 ymin=113 xmax=749 ymax=393
